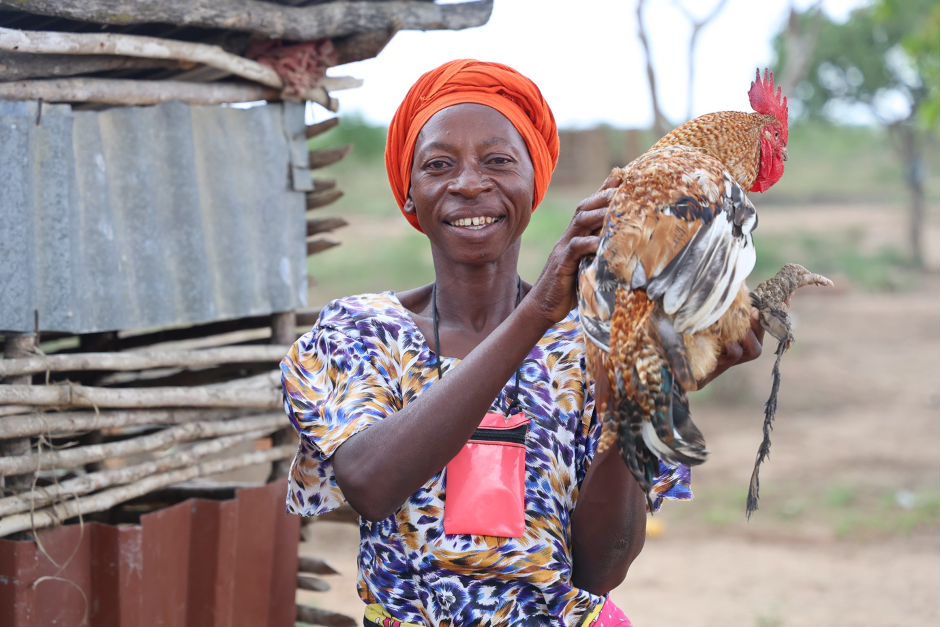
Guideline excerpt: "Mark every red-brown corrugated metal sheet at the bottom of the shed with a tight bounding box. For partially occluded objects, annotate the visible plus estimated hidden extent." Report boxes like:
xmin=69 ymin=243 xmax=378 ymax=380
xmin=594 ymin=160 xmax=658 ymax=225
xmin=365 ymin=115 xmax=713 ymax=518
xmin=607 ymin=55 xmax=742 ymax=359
xmin=0 ymin=480 xmax=300 ymax=627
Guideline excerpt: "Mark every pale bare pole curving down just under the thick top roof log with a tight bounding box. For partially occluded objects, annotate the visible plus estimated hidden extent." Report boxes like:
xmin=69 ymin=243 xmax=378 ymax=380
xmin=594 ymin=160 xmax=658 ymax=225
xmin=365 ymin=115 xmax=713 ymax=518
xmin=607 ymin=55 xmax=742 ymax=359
xmin=0 ymin=27 xmax=284 ymax=89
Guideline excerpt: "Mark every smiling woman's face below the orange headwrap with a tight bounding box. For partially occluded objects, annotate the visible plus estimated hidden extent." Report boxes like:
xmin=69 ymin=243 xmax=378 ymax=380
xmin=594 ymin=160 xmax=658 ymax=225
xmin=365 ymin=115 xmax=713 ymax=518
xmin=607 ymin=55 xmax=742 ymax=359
xmin=405 ymin=104 xmax=535 ymax=264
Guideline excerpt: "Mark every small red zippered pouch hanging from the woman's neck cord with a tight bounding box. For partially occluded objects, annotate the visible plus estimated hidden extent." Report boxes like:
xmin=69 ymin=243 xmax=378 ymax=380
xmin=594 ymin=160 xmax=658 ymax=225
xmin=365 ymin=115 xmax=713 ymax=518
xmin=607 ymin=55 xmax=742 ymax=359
xmin=444 ymin=412 xmax=529 ymax=538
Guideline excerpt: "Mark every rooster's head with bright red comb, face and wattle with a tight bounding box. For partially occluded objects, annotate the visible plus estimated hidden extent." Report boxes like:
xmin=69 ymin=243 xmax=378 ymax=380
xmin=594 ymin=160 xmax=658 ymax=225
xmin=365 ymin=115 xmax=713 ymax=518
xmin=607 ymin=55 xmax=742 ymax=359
xmin=748 ymin=68 xmax=787 ymax=192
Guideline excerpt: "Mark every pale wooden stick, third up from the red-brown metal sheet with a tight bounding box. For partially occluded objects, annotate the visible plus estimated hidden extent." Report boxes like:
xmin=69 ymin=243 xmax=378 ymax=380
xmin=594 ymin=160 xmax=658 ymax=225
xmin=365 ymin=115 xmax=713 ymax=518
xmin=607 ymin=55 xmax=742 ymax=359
xmin=0 ymin=413 xmax=286 ymax=476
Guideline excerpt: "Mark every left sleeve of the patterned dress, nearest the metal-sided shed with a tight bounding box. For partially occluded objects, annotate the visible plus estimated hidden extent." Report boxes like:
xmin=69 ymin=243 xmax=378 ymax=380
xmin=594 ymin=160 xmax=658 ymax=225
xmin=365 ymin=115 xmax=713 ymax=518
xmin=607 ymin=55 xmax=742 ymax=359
xmin=281 ymin=320 xmax=401 ymax=516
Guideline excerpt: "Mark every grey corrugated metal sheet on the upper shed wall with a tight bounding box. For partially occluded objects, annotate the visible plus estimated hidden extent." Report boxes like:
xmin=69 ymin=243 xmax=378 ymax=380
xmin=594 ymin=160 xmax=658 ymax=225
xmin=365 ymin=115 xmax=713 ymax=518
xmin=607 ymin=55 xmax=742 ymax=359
xmin=0 ymin=101 xmax=310 ymax=333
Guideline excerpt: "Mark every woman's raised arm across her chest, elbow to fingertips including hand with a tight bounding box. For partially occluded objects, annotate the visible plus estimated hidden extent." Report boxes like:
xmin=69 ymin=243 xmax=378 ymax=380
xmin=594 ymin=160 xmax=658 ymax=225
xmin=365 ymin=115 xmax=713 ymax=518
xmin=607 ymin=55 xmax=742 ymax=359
xmin=333 ymin=188 xmax=613 ymax=521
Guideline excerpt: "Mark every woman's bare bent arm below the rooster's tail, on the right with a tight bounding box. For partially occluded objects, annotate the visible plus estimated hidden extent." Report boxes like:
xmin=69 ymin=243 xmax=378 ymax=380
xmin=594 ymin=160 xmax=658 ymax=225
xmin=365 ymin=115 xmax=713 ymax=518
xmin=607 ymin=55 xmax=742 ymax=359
xmin=572 ymin=447 xmax=647 ymax=595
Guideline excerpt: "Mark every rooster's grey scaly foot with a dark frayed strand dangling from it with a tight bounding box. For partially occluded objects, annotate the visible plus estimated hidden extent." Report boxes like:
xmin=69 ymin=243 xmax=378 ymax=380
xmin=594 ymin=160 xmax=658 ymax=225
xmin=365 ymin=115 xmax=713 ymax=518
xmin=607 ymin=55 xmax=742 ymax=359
xmin=745 ymin=263 xmax=833 ymax=517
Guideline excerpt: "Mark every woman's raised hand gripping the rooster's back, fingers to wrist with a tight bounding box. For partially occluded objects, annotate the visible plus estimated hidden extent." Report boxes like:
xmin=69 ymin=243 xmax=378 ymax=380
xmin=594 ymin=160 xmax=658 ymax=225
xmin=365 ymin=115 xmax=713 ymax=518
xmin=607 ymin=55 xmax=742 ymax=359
xmin=527 ymin=171 xmax=619 ymax=326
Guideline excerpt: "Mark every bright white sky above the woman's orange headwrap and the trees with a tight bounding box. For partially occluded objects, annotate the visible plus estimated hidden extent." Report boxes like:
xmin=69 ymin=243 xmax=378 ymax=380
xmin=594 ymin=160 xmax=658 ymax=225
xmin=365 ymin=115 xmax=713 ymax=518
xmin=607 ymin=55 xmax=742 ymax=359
xmin=313 ymin=0 xmax=865 ymax=128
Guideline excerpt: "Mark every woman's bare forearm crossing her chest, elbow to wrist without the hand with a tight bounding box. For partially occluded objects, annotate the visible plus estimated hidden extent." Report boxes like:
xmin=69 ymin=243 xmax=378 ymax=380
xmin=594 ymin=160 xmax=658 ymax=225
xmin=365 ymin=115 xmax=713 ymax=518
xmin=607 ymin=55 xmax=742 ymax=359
xmin=334 ymin=299 xmax=550 ymax=520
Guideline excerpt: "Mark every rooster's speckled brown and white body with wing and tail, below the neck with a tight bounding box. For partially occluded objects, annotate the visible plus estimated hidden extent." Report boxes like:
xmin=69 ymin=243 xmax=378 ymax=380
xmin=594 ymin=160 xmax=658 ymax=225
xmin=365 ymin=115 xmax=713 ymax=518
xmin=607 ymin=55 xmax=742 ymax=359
xmin=579 ymin=146 xmax=757 ymax=502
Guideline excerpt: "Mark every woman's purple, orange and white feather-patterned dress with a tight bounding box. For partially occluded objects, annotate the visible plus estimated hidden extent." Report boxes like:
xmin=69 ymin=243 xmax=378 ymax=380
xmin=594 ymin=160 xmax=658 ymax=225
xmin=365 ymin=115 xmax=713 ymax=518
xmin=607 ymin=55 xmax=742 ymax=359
xmin=281 ymin=292 xmax=690 ymax=627
